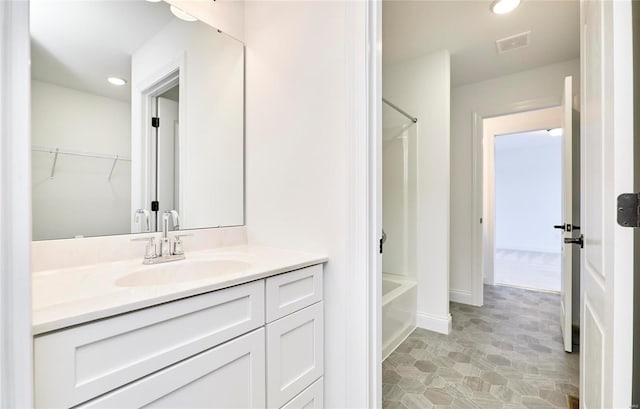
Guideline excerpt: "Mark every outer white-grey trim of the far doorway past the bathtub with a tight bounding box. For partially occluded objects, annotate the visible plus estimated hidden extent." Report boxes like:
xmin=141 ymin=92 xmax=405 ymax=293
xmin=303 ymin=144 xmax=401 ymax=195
xmin=471 ymin=97 xmax=560 ymax=306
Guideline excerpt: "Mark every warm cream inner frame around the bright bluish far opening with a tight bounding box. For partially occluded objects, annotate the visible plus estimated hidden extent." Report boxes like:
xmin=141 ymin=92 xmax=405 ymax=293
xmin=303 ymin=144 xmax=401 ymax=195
xmin=482 ymin=106 xmax=562 ymax=285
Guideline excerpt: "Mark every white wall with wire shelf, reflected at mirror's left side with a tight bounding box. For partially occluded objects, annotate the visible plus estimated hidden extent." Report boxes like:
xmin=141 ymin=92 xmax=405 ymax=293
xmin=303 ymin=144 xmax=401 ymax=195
xmin=31 ymin=80 xmax=131 ymax=240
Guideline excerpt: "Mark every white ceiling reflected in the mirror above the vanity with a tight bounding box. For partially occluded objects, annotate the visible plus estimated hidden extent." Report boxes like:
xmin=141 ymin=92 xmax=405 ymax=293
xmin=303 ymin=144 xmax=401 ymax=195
xmin=30 ymin=0 xmax=174 ymax=101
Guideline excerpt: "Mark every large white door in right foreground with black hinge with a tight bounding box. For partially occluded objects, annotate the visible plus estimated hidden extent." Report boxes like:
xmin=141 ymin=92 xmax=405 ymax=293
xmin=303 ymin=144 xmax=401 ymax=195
xmin=574 ymin=0 xmax=633 ymax=409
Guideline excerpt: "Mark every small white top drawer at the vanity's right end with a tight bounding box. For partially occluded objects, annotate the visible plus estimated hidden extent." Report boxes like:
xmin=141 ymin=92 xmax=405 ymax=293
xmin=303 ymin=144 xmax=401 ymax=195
xmin=267 ymin=265 xmax=322 ymax=322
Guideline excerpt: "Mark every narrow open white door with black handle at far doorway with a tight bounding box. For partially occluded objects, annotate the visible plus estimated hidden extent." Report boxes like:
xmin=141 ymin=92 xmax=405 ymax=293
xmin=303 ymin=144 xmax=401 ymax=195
xmin=560 ymin=77 xmax=579 ymax=352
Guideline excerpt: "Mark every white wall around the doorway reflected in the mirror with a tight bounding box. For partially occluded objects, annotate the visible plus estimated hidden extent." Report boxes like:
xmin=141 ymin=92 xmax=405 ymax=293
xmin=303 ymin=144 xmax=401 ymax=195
xmin=131 ymin=19 xmax=244 ymax=229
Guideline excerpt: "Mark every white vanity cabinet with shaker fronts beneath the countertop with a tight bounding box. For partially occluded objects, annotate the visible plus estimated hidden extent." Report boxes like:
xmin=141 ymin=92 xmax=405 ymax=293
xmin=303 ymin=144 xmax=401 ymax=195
xmin=34 ymin=265 xmax=324 ymax=409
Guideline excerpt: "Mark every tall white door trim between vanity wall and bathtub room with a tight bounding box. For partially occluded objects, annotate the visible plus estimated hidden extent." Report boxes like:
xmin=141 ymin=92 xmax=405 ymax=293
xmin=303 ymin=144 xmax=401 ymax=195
xmin=343 ymin=1 xmax=382 ymax=408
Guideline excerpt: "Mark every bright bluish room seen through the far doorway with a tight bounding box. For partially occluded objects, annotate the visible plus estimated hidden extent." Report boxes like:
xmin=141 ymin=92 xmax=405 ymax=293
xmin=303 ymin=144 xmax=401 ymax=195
xmin=493 ymin=128 xmax=562 ymax=293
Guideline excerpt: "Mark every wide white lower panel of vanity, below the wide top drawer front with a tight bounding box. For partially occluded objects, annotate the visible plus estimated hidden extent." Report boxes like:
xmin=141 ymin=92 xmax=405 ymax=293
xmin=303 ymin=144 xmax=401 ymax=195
xmin=78 ymin=328 xmax=265 ymax=409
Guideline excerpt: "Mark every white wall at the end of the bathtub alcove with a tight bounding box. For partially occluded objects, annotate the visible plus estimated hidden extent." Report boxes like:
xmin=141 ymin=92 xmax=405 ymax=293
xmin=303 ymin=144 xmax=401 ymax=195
xmin=382 ymin=50 xmax=451 ymax=333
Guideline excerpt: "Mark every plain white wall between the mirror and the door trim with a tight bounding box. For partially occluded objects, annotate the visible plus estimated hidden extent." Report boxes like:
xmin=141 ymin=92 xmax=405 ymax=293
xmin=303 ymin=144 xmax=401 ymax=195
xmin=245 ymin=1 xmax=372 ymax=408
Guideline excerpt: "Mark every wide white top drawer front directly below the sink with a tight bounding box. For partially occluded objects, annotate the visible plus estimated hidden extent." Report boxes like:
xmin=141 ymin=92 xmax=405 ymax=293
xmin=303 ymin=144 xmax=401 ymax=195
xmin=34 ymin=280 xmax=264 ymax=407
